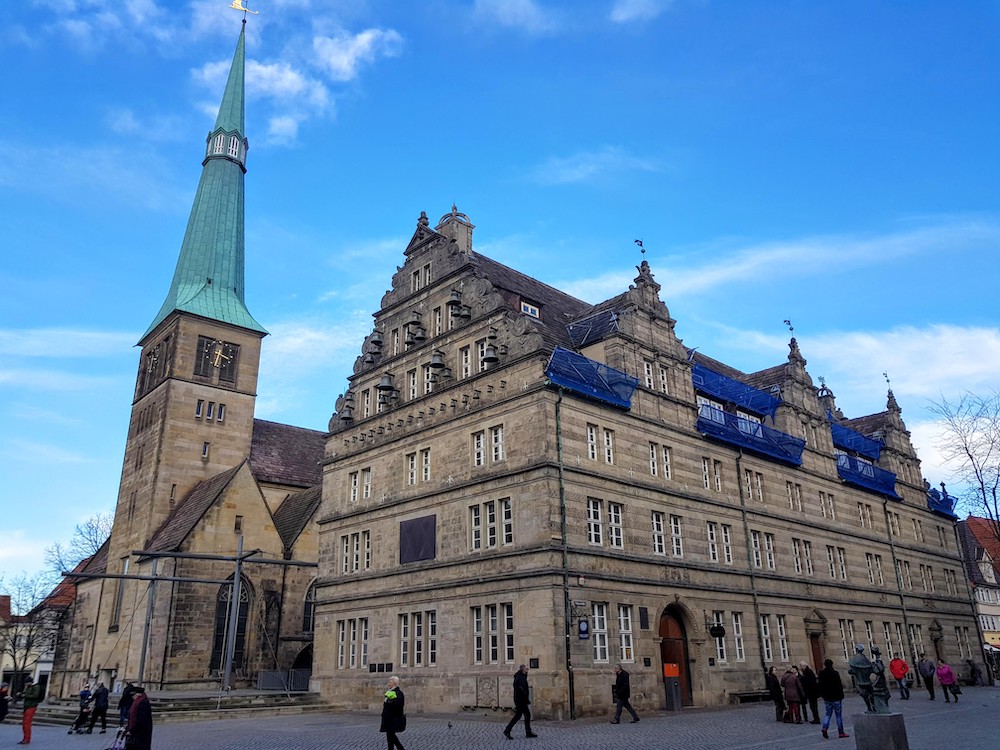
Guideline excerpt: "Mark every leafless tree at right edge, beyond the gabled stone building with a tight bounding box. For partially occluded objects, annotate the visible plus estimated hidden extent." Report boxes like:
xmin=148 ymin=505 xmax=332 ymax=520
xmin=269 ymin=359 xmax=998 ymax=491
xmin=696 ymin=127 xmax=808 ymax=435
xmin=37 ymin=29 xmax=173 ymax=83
xmin=931 ymin=391 xmax=1000 ymax=541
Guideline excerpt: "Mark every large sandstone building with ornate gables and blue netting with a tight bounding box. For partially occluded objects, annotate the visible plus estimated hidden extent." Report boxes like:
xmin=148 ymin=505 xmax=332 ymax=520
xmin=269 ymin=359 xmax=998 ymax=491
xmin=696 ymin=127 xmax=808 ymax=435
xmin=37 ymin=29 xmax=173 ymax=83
xmin=313 ymin=209 xmax=979 ymax=718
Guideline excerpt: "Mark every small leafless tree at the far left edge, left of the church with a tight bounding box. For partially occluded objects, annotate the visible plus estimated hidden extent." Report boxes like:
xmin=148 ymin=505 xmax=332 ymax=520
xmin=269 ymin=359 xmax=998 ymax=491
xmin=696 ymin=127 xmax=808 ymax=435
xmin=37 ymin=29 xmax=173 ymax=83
xmin=0 ymin=573 xmax=67 ymax=685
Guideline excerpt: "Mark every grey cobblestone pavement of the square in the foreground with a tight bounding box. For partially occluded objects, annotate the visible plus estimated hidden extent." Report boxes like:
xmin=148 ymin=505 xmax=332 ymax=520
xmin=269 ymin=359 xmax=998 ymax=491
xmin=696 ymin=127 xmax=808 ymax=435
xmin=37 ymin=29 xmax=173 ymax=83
xmin=0 ymin=688 xmax=1000 ymax=750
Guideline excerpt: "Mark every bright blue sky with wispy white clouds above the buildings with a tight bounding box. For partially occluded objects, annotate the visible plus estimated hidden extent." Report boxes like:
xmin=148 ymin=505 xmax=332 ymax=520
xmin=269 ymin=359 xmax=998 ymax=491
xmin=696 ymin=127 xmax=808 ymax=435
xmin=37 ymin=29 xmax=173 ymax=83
xmin=0 ymin=0 xmax=1000 ymax=577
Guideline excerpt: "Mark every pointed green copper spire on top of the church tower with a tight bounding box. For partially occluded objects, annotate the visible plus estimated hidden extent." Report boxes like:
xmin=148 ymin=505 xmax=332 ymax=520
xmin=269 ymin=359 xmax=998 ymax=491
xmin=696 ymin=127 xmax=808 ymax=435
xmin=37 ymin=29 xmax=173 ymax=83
xmin=142 ymin=22 xmax=267 ymax=339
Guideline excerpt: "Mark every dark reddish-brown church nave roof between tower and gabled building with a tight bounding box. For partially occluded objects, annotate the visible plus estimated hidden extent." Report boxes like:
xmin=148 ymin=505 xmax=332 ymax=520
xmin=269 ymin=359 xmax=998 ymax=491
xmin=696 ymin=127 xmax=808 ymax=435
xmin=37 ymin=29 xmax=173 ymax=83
xmin=250 ymin=419 xmax=326 ymax=488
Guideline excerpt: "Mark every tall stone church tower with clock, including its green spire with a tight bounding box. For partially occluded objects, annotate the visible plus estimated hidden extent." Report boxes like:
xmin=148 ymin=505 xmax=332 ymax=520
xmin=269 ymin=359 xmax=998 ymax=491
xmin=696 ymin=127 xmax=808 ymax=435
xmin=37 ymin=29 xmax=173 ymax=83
xmin=108 ymin=22 xmax=267 ymax=604
